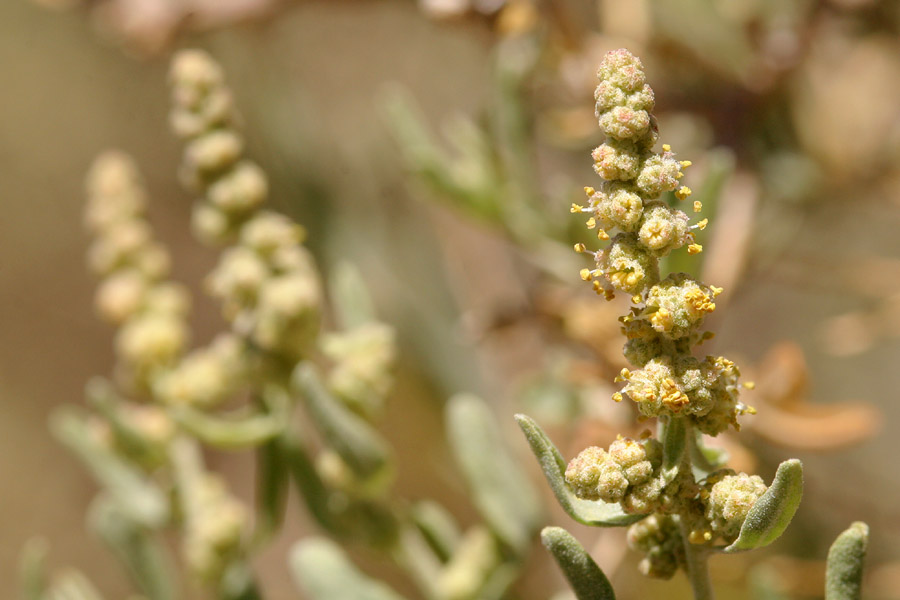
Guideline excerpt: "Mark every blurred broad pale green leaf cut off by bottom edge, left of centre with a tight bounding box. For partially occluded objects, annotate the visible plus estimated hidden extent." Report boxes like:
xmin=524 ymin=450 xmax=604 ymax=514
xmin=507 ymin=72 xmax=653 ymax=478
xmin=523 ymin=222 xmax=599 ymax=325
xmin=289 ymin=537 xmax=403 ymax=600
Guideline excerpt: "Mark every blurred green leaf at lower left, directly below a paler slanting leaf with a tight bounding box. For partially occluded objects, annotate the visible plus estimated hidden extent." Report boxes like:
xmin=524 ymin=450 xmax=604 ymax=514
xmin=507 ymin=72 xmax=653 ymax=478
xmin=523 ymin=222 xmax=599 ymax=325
xmin=88 ymin=495 xmax=178 ymax=600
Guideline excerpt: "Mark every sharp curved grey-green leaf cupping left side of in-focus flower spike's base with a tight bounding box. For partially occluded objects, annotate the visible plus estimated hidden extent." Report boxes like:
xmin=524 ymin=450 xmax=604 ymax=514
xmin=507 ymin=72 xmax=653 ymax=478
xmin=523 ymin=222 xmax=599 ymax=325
xmin=516 ymin=415 xmax=646 ymax=527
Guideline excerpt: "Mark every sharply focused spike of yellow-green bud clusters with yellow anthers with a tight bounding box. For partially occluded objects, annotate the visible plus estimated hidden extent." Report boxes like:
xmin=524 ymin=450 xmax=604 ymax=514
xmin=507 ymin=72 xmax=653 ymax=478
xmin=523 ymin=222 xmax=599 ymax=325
xmin=565 ymin=50 xmax=766 ymax=577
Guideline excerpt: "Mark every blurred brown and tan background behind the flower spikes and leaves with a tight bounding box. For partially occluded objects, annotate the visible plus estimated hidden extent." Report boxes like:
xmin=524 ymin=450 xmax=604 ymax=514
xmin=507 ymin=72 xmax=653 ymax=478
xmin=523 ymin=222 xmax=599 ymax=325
xmin=0 ymin=0 xmax=900 ymax=599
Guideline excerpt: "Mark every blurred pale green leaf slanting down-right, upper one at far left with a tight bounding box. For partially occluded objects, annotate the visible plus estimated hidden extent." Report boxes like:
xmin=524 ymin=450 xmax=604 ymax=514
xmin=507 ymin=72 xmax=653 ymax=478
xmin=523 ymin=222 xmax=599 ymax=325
xmin=50 ymin=410 xmax=169 ymax=528
